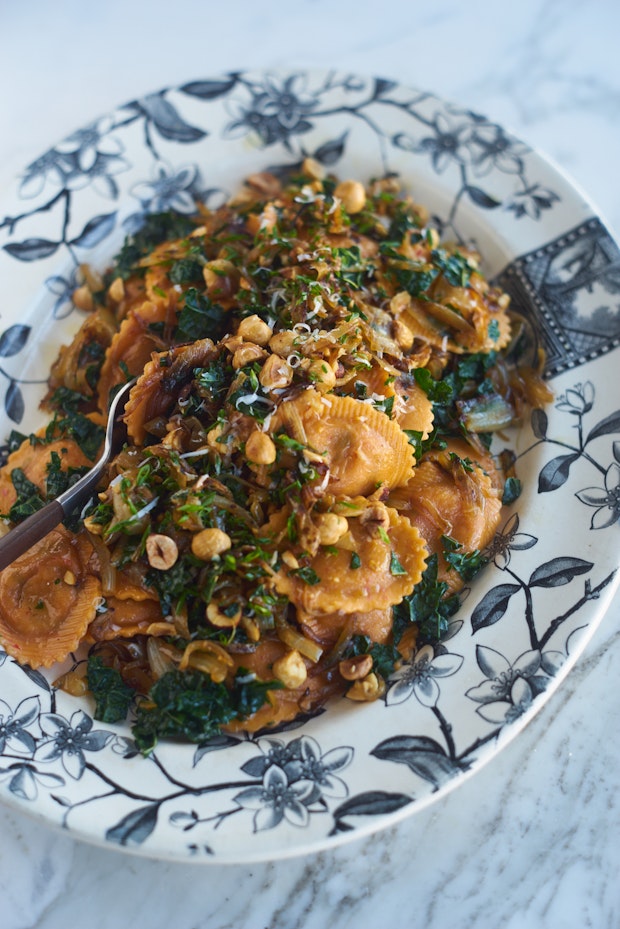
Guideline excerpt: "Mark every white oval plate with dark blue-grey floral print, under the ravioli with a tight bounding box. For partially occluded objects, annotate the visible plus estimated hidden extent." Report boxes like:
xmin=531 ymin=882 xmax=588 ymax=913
xmin=0 ymin=72 xmax=620 ymax=862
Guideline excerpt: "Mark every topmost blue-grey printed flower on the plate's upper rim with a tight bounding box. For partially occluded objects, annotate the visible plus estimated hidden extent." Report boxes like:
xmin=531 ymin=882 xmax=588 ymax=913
xmin=224 ymin=74 xmax=318 ymax=145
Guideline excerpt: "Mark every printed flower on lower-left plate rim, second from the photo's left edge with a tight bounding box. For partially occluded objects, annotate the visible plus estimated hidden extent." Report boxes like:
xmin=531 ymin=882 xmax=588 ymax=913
xmin=34 ymin=710 xmax=114 ymax=780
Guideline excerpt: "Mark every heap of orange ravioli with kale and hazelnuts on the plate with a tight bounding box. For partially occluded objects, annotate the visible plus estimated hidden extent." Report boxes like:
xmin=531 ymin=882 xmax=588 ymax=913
xmin=0 ymin=165 xmax=548 ymax=751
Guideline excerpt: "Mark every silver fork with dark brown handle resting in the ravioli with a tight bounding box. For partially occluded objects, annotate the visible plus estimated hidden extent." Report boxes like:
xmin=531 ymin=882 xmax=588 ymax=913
xmin=0 ymin=378 xmax=136 ymax=571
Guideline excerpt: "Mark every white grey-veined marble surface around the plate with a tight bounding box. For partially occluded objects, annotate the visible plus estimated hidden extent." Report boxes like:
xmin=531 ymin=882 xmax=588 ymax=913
xmin=0 ymin=0 xmax=620 ymax=929
